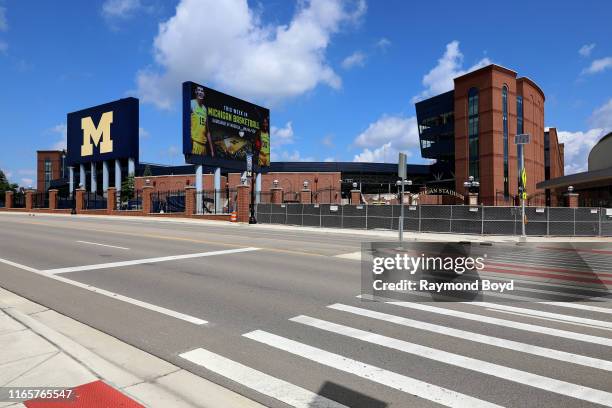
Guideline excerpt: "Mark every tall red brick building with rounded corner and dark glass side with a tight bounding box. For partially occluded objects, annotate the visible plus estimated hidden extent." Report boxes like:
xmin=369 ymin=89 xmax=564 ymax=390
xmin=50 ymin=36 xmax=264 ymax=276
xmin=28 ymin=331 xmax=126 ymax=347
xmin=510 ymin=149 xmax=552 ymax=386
xmin=416 ymin=64 xmax=563 ymax=205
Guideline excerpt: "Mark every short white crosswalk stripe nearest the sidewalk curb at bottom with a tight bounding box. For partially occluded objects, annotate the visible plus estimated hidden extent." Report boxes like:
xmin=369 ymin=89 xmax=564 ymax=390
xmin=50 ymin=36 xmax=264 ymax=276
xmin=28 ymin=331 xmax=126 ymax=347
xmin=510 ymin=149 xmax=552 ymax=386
xmin=179 ymin=348 xmax=348 ymax=408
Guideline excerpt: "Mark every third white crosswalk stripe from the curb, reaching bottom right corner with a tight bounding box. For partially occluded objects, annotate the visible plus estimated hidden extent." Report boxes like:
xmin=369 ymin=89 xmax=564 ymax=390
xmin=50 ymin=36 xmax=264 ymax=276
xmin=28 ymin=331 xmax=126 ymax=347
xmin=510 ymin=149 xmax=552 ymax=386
xmin=289 ymin=316 xmax=612 ymax=407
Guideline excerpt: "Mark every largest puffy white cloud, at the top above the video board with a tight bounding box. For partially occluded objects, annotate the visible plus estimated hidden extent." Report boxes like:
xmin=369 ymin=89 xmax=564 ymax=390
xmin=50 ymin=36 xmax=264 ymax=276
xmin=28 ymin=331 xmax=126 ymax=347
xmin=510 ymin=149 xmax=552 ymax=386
xmin=137 ymin=0 xmax=366 ymax=109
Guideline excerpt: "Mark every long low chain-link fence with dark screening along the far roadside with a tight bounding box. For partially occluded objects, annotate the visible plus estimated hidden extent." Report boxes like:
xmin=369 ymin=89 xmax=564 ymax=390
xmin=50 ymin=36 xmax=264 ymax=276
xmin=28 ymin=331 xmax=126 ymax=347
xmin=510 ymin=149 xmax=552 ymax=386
xmin=256 ymin=204 xmax=612 ymax=236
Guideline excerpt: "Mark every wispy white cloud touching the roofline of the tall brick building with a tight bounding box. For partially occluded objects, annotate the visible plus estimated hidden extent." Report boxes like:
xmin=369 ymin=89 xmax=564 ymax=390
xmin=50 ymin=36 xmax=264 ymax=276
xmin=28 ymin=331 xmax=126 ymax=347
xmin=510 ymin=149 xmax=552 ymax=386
xmin=412 ymin=40 xmax=491 ymax=102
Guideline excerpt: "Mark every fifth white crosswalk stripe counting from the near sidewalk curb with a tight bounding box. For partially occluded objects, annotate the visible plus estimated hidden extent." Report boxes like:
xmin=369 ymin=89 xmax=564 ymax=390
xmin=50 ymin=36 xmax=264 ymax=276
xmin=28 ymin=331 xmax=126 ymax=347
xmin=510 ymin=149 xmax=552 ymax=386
xmin=361 ymin=296 xmax=612 ymax=347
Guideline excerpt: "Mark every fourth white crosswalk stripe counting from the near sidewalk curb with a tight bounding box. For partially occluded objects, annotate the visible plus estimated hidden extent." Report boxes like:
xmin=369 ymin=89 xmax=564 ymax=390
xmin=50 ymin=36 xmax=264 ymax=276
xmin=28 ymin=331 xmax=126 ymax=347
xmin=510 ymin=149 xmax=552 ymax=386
xmin=328 ymin=303 xmax=612 ymax=371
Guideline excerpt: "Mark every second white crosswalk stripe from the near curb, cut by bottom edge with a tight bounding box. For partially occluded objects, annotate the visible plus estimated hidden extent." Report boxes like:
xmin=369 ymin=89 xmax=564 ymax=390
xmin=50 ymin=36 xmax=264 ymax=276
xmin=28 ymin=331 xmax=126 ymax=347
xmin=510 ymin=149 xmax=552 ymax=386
xmin=243 ymin=330 xmax=500 ymax=408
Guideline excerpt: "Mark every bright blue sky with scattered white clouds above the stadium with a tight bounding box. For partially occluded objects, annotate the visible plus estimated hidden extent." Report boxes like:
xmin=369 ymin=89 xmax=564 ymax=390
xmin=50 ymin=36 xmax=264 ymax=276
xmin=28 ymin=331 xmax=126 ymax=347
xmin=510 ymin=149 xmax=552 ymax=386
xmin=0 ymin=0 xmax=612 ymax=185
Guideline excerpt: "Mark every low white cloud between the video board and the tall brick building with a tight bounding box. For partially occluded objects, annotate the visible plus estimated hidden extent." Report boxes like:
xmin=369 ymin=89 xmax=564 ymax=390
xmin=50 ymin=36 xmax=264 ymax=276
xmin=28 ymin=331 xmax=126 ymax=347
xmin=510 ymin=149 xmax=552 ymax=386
xmin=353 ymin=115 xmax=419 ymax=163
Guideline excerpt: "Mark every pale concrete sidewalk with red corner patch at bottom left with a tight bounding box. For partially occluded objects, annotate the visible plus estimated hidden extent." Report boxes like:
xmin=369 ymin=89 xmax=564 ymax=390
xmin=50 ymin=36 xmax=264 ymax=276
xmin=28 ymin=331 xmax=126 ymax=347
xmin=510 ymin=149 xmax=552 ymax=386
xmin=0 ymin=288 xmax=262 ymax=408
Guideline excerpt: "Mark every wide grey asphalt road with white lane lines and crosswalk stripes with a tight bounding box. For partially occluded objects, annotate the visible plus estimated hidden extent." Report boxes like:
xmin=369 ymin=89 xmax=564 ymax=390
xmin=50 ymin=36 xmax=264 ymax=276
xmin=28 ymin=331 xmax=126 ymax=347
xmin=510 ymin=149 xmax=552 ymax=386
xmin=0 ymin=213 xmax=612 ymax=408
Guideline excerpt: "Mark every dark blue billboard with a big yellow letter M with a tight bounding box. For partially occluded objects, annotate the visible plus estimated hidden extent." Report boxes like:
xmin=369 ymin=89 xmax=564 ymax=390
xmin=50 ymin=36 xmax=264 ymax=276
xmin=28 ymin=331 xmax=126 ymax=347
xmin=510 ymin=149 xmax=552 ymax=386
xmin=66 ymin=98 xmax=139 ymax=166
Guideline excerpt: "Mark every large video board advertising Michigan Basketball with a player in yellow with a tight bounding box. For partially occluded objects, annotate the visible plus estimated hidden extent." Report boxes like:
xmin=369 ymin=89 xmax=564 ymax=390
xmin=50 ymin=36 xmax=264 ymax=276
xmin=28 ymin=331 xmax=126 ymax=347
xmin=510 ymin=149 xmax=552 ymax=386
xmin=183 ymin=82 xmax=270 ymax=171
